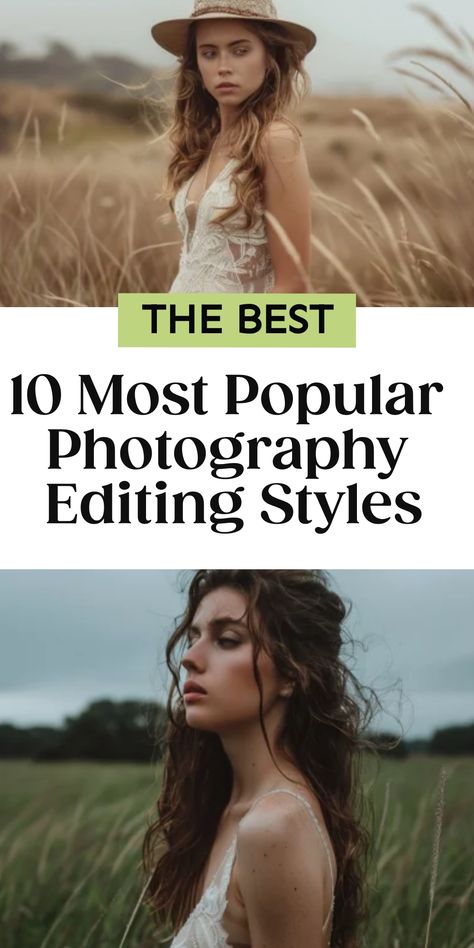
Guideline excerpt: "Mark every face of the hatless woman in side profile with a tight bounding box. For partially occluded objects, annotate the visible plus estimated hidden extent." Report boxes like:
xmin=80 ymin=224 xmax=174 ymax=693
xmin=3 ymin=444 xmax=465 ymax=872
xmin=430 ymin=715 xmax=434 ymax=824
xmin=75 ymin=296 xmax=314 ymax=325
xmin=182 ymin=586 xmax=284 ymax=733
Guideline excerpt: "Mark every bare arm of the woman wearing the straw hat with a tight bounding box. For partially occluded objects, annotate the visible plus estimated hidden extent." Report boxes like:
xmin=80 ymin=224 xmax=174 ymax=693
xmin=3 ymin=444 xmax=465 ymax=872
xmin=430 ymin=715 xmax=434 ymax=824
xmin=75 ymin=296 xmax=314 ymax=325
xmin=263 ymin=122 xmax=311 ymax=293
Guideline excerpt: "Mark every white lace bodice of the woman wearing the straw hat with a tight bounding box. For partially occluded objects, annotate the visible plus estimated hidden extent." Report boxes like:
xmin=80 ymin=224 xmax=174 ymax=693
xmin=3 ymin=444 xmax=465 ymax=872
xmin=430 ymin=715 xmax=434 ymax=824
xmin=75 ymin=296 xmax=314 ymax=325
xmin=169 ymin=158 xmax=274 ymax=293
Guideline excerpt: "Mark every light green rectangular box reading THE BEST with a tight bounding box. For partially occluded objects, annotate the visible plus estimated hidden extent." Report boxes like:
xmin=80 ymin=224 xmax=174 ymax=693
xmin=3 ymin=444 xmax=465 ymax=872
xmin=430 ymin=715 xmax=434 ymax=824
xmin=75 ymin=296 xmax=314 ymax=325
xmin=118 ymin=293 xmax=356 ymax=349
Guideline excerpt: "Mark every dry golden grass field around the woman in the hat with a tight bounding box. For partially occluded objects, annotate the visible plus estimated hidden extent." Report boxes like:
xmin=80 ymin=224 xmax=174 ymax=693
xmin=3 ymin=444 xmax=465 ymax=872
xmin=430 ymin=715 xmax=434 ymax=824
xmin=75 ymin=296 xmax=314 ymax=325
xmin=0 ymin=40 xmax=474 ymax=306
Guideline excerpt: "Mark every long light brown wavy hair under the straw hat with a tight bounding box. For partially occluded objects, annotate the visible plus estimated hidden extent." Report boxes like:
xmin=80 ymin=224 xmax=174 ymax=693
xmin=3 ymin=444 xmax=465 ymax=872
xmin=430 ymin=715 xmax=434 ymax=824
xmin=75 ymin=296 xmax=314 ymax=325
xmin=163 ymin=19 xmax=309 ymax=227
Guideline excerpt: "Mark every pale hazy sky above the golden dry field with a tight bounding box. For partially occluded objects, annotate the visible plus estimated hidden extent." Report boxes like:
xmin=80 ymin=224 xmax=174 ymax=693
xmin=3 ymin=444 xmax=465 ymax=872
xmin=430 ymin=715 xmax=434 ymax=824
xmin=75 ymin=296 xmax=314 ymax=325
xmin=0 ymin=0 xmax=474 ymax=94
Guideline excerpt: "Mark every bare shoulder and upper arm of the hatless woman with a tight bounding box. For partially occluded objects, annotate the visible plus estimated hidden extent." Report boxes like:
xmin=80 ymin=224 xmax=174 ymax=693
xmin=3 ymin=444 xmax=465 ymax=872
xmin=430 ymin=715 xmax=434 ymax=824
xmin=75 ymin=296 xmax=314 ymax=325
xmin=237 ymin=801 xmax=331 ymax=948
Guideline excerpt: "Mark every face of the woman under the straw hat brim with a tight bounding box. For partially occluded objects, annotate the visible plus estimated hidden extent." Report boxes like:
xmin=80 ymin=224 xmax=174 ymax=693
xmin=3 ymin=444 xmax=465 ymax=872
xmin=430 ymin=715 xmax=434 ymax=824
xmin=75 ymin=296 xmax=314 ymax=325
xmin=196 ymin=20 xmax=267 ymax=106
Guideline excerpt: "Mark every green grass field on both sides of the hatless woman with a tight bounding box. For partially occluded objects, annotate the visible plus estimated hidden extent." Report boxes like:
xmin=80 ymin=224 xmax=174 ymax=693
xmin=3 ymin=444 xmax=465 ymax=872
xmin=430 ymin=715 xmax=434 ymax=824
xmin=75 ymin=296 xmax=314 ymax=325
xmin=0 ymin=757 xmax=474 ymax=948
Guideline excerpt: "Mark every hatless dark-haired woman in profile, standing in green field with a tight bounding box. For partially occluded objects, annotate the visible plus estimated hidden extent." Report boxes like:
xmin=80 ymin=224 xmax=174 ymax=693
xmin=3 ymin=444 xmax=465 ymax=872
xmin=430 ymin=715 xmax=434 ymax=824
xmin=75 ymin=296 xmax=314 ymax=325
xmin=144 ymin=569 xmax=372 ymax=948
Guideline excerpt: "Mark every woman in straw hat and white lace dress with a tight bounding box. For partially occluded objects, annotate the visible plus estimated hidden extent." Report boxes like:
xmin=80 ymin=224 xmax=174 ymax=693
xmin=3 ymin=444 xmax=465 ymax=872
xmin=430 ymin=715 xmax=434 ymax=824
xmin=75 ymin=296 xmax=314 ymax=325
xmin=152 ymin=0 xmax=316 ymax=293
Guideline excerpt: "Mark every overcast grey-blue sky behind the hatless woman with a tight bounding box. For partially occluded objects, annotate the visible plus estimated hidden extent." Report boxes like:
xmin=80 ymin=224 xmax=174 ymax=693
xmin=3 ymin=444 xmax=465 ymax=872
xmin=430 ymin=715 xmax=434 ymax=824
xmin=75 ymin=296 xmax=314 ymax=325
xmin=0 ymin=570 xmax=474 ymax=737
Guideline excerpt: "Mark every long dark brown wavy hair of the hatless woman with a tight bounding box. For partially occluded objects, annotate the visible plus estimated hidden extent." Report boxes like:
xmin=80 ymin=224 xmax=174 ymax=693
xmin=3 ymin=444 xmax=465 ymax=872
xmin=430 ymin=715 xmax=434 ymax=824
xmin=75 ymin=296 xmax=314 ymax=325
xmin=144 ymin=569 xmax=377 ymax=948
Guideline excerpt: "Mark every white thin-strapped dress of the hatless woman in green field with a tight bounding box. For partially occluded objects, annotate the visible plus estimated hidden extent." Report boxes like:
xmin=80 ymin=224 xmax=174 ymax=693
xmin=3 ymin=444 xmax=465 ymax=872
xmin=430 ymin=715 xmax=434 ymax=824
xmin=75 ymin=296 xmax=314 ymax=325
xmin=169 ymin=788 xmax=335 ymax=948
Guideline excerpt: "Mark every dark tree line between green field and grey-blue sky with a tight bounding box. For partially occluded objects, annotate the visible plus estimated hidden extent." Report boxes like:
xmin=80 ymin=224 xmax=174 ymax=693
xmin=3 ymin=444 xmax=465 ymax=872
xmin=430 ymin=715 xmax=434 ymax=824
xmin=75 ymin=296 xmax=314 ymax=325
xmin=0 ymin=698 xmax=474 ymax=763
